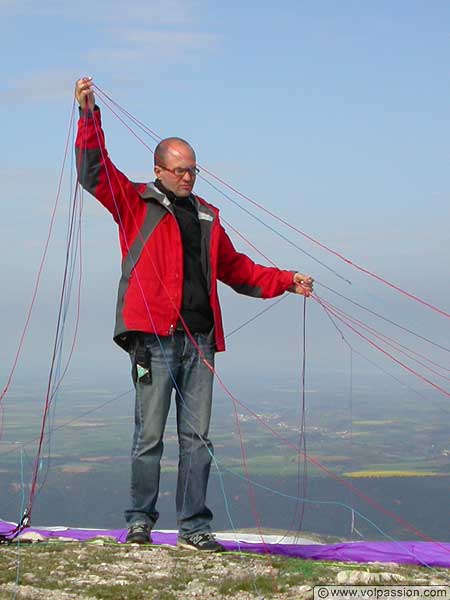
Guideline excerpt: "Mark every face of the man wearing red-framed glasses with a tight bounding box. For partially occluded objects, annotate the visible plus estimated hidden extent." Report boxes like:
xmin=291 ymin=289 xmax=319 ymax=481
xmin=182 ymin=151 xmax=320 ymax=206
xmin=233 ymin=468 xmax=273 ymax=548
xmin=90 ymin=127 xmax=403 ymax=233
xmin=154 ymin=143 xmax=196 ymax=198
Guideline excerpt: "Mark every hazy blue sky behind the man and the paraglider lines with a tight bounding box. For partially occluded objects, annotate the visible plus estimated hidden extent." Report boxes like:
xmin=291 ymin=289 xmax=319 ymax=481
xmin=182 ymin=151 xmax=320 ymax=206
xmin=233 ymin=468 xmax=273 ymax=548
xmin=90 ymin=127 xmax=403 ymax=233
xmin=0 ymin=0 xmax=450 ymax=406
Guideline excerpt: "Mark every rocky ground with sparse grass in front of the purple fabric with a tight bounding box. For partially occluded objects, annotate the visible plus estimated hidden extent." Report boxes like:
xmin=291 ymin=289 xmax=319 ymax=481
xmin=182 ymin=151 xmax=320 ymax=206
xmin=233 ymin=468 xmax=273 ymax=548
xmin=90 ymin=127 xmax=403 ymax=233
xmin=0 ymin=539 xmax=450 ymax=600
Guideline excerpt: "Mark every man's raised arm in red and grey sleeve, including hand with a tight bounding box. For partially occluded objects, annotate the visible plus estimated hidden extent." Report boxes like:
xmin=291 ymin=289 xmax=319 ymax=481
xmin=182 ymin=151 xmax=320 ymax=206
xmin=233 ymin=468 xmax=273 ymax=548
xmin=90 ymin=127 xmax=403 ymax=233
xmin=75 ymin=77 xmax=137 ymax=223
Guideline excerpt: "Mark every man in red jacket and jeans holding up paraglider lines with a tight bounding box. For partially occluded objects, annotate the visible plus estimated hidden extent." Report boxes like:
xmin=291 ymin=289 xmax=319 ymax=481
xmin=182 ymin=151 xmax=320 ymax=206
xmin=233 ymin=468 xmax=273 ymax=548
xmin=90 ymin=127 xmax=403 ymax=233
xmin=75 ymin=78 xmax=313 ymax=552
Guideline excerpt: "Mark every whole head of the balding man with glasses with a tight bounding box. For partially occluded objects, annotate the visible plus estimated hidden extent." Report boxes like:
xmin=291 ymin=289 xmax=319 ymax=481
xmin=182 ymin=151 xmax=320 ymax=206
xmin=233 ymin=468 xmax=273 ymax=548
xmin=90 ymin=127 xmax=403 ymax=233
xmin=154 ymin=137 xmax=197 ymax=198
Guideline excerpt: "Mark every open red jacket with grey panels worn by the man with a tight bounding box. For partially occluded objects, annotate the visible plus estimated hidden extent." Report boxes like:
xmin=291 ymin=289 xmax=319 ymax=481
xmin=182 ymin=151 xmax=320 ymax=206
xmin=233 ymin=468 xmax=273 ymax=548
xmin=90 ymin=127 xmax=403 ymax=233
xmin=75 ymin=108 xmax=293 ymax=351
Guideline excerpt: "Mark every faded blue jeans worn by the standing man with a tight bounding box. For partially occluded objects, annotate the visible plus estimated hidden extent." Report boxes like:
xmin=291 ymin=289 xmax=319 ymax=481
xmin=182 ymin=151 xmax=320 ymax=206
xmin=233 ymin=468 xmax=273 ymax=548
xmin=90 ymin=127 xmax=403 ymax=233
xmin=125 ymin=331 xmax=214 ymax=534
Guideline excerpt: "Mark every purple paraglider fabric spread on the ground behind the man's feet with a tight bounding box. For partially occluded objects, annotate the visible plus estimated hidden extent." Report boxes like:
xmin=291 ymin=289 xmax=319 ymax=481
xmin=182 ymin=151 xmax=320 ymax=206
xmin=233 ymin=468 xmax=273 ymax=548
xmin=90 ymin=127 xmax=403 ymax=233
xmin=0 ymin=520 xmax=450 ymax=567
